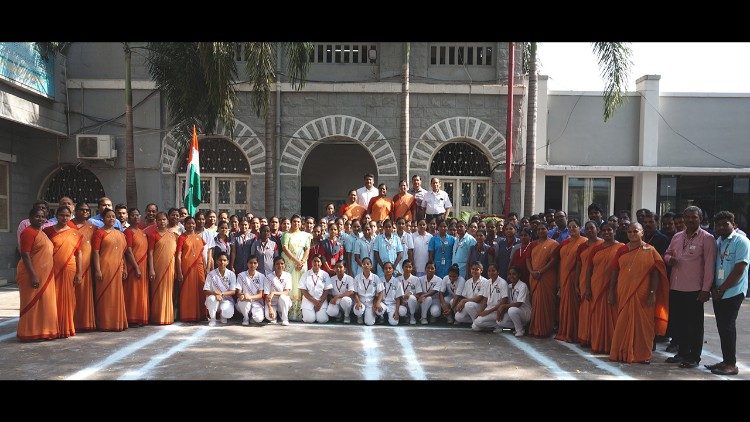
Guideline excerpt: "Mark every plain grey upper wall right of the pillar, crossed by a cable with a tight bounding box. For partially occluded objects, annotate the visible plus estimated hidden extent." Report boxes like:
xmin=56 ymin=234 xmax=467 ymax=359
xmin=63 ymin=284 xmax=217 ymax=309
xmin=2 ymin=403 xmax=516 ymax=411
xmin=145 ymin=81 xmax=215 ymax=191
xmin=659 ymin=94 xmax=750 ymax=167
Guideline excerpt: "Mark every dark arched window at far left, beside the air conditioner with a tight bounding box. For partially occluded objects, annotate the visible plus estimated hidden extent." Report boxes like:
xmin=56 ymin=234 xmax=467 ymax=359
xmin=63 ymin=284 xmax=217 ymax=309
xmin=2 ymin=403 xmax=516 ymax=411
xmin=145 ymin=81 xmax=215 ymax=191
xmin=42 ymin=165 xmax=105 ymax=211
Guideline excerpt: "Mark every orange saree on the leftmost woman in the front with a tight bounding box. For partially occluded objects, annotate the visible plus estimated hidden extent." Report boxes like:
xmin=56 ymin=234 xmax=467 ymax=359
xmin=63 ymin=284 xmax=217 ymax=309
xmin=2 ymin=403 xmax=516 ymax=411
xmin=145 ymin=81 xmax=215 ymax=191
xmin=16 ymin=227 xmax=60 ymax=341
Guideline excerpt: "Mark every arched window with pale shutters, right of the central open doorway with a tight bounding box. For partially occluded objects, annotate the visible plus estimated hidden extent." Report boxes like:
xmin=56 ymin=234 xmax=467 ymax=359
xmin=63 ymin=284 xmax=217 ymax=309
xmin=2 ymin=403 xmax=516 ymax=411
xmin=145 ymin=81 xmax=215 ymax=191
xmin=430 ymin=142 xmax=492 ymax=215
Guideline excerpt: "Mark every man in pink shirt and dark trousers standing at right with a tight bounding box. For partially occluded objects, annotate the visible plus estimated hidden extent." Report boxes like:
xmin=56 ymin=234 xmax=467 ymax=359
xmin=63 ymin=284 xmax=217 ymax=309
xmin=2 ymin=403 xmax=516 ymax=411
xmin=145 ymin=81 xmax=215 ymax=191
xmin=664 ymin=206 xmax=716 ymax=368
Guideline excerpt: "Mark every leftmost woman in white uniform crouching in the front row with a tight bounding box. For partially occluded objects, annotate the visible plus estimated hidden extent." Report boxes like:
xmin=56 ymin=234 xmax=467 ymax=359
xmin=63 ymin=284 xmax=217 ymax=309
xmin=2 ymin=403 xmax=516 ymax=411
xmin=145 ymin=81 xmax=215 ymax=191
xmin=203 ymin=252 xmax=237 ymax=327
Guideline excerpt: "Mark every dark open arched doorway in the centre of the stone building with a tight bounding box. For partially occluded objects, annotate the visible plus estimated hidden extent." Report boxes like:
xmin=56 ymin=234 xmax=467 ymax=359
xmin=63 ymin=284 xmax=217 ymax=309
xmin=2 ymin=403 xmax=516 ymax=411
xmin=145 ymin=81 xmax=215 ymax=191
xmin=301 ymin=140 xmax=378 ymax=218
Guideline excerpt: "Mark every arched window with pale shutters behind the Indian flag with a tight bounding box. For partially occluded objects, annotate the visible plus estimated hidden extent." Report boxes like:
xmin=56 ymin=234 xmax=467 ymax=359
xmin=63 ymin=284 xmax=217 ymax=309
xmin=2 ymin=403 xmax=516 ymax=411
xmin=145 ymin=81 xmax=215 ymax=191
xmin=175 ymin=137 xmax=250 ymax=216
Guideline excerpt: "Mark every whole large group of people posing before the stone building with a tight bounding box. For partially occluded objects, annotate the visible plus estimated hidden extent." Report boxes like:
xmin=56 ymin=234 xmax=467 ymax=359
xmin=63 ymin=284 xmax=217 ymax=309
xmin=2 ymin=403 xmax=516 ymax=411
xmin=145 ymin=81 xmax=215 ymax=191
xmin=17 ymin=174 xmax=748 ymax=374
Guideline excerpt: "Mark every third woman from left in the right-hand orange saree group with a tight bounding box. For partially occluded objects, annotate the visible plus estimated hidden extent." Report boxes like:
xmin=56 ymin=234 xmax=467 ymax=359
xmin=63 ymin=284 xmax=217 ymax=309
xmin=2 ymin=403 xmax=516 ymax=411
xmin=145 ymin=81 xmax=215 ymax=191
xmin=575 ymin=221 xmax=604 ymax=347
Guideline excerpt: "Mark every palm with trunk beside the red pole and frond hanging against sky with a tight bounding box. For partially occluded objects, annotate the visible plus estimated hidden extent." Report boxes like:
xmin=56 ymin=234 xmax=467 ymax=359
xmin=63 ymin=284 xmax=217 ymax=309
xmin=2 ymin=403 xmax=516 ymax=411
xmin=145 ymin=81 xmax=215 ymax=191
xmin=524 ymin=42 xmax=632 ymax=215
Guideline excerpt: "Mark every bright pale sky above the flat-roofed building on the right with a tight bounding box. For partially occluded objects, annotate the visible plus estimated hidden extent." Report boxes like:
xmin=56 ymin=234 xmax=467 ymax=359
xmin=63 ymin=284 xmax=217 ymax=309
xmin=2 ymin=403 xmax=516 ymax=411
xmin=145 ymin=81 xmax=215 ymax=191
xmin=537 ymin=43 xmax=750 ymax=93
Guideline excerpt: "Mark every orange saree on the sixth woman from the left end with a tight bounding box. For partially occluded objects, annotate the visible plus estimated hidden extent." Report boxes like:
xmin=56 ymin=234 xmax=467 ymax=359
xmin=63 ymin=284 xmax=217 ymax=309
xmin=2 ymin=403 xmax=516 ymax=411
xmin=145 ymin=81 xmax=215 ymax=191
xmin=148 ymin=230 xmax=177 ymax=325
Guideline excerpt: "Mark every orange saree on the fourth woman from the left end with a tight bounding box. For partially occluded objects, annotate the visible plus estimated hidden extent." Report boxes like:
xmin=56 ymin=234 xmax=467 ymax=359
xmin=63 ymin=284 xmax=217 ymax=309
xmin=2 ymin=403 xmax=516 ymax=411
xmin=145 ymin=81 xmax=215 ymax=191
xmin=93 ymin=228 xmax=128 ymax=331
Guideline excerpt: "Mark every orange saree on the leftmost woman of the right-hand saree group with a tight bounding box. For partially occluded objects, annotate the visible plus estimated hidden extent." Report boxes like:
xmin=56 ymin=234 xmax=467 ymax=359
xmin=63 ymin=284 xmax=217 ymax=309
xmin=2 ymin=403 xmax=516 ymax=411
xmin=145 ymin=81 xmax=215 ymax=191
xmin=529 ymin=239 xmax=559 ymax=337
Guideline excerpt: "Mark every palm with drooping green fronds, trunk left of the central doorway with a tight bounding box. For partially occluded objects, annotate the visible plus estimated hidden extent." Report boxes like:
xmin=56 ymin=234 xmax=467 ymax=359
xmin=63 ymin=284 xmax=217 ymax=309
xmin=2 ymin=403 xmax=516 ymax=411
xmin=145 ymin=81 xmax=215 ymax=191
xmin=147 ymin=42 xmax=313 ymax=215
